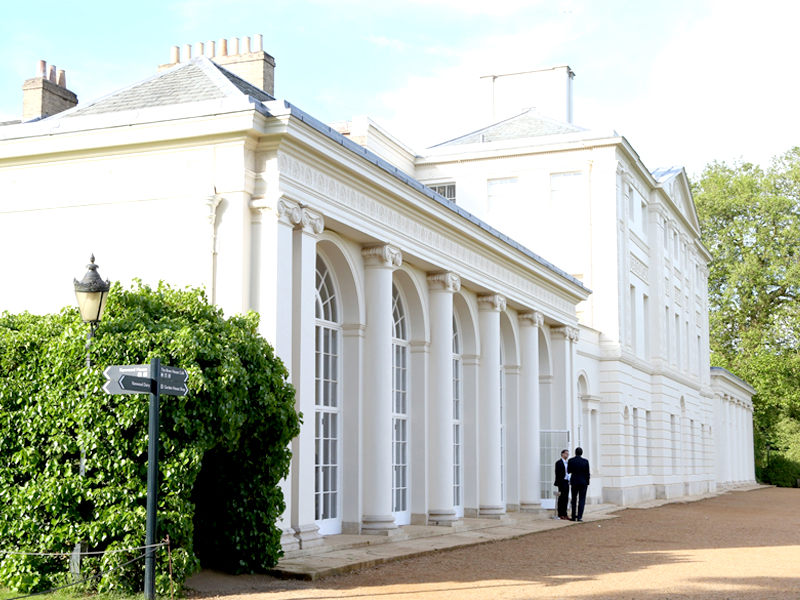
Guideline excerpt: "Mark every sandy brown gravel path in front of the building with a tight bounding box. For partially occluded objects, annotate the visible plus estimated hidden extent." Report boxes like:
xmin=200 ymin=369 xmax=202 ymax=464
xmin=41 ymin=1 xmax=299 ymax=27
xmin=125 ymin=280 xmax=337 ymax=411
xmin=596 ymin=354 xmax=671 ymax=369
xmin=192 ymin=488 xmax=800 ymax=600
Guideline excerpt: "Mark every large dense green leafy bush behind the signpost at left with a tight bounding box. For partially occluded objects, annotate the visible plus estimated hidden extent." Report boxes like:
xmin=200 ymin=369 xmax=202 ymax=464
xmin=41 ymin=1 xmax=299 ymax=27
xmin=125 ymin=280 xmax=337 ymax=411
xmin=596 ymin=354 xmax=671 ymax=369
xmin=0 ymin=284 xmax=299 ymax=593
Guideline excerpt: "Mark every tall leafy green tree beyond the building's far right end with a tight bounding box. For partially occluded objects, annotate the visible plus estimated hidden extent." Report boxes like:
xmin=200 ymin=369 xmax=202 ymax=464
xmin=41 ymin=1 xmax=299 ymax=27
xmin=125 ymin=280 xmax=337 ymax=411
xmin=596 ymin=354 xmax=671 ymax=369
xmin=693 ymin=147 xmax=800 ymax=478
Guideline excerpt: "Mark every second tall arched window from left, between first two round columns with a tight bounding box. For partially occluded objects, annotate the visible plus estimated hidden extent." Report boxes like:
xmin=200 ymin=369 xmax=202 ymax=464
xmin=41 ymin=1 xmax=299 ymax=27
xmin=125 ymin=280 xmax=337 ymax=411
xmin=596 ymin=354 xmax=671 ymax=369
xmin=392 ymin=285 xmax=411 ymax=525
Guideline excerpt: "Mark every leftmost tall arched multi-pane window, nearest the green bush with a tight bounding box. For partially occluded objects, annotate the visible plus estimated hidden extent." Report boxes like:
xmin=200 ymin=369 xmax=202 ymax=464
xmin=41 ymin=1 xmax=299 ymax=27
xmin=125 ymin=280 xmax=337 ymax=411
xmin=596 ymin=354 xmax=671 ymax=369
xmin=314 ymin=255 xmax=342 ymax=534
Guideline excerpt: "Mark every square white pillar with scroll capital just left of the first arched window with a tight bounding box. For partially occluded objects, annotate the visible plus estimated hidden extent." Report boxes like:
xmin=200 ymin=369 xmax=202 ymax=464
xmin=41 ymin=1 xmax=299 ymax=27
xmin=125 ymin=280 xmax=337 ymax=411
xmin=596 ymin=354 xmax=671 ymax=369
xmin=290 ymin=204 xmax=324 ymax=548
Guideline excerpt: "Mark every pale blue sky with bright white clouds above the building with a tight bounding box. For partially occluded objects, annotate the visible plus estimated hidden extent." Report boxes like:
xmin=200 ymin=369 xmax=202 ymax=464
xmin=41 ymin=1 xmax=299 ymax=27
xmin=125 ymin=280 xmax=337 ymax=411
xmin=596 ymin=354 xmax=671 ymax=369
xmin=0 ymin=0 xmax=800 ymax=174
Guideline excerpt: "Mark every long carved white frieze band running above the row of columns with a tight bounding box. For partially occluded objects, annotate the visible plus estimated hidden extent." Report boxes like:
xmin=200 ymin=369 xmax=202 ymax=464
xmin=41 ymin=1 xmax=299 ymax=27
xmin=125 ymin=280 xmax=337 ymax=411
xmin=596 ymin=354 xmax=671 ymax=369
xmin=278 ymin=152 xmax=575 ymax=314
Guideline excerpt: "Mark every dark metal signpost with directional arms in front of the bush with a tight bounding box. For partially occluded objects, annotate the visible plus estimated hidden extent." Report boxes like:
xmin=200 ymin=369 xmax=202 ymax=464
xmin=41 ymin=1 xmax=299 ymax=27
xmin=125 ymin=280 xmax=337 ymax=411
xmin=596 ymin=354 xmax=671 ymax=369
xmin=103 ymin=358 xmax=189 ymax=600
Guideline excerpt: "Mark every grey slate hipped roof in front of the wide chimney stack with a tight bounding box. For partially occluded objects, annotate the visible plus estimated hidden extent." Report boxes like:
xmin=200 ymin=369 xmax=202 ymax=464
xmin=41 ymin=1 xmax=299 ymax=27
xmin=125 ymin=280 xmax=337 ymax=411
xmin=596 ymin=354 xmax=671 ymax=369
xmin=63 ymin=56 xmax=274 ymax=118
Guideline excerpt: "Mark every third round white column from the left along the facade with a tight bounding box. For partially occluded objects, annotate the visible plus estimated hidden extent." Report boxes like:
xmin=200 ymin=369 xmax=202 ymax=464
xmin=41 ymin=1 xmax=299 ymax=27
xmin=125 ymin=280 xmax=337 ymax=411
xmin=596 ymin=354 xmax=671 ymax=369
xmin=478 ymin=294 xmax=506 ymax=517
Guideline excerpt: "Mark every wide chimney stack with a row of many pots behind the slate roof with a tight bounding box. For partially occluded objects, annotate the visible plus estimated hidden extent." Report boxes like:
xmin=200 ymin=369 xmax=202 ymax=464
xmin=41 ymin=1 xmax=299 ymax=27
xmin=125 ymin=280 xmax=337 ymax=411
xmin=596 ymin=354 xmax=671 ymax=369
xmin=158 ymin=34 xmax=275 ymax=96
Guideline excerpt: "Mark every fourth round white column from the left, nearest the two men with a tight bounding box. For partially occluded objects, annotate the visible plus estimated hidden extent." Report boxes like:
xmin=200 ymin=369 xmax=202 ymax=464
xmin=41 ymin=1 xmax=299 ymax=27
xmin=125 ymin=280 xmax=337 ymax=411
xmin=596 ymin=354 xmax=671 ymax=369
xmin=519 ymin=312 xmax=544 ymax=511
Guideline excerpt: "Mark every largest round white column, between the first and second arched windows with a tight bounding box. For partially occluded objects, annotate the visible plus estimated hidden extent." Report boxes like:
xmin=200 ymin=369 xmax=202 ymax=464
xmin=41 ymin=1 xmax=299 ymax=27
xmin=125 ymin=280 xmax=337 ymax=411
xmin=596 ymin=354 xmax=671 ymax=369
xmin=361 ymin=245 xmax=403 ymax=535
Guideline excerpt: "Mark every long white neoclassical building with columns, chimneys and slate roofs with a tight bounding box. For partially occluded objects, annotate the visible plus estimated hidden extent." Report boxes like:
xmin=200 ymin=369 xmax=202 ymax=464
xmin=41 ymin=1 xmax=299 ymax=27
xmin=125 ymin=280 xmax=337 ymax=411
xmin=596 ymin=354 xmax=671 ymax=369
xmin=0 ymin=36 xmax=754 ymax=549
